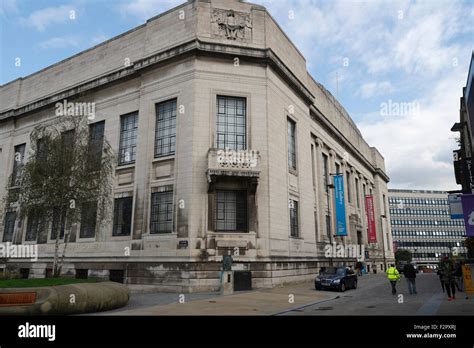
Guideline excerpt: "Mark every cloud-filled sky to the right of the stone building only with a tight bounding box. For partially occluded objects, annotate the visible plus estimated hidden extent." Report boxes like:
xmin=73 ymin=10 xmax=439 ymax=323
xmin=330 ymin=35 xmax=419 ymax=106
xmin=254 ymin=0 xmax=474 ymax=189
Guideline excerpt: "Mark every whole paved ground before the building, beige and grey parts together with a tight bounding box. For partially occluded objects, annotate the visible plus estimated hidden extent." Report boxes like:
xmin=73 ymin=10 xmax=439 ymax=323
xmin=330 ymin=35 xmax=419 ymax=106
xmin=93 ymin=274 xmax=474 ymax=316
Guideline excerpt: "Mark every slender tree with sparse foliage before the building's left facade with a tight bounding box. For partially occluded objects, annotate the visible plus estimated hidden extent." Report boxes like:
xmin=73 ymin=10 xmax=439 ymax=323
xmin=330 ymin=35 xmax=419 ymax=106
xmin=4 ymin=116 xmax=116 ymax=277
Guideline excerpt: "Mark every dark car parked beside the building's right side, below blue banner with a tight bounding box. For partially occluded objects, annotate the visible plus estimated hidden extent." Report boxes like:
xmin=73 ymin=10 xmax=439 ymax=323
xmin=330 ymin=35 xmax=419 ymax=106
xmin=314 ymin=266 xmax=357 ymax=292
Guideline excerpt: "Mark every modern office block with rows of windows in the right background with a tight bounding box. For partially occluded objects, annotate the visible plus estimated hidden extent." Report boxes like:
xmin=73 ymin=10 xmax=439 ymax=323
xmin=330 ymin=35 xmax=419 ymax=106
xmin=388 ymin=190 xmax=466 ymax=268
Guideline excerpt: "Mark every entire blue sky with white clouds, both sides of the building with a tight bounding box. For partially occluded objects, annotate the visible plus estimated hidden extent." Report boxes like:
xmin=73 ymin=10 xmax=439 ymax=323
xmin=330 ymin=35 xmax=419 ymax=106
xmin=0 ymin=0 xmax=474 ymax=190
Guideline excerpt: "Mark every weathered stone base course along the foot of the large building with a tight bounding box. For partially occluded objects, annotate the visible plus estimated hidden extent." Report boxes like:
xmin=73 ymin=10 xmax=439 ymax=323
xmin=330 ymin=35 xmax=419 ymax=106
xmin=0 ymin=258 xmax=378 ymax=293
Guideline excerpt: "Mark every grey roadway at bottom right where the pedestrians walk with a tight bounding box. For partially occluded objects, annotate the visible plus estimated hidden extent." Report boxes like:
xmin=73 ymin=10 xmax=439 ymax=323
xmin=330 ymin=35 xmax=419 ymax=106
xmin=280 ymin=274 xmax=474 ymax=316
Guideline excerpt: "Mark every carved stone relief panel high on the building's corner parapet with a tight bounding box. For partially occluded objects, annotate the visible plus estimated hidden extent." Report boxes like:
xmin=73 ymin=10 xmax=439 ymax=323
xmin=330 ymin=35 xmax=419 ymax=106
xmin=211 ymin=8 xmax=252 ymax=41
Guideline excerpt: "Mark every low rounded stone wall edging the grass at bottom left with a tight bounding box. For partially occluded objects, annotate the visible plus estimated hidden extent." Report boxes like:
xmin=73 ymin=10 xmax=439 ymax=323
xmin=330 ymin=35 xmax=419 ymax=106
xmin=0 ymin=282 xmax=130 ymax=316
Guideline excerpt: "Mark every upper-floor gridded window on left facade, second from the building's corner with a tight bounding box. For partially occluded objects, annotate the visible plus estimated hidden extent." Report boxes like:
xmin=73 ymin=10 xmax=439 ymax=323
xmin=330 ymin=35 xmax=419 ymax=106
xmin=119 ymin=112 xmax=138 ymax=165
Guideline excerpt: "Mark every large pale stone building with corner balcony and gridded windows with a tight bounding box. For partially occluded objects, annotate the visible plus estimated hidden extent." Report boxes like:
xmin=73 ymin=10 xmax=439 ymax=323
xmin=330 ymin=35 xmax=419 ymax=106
xmin=0 ymin=0 xmax=393 ymax=291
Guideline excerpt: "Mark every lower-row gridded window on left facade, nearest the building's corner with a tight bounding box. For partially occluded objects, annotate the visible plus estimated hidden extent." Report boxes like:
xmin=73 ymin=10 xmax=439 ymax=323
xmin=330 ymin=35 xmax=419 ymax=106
xmin=150 ymin=190 xmax=173 ymax=233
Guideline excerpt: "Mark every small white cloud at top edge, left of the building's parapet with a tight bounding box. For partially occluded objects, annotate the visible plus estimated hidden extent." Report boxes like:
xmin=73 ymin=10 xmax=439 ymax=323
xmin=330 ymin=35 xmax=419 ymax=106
xmin=118 ymin=0 xmax=184 ymax=20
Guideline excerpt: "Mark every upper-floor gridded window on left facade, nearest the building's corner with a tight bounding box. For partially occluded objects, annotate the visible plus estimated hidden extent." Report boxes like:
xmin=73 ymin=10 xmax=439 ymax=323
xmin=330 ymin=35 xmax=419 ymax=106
xmin=155 ymin=99 xmax=177 ymax=157
